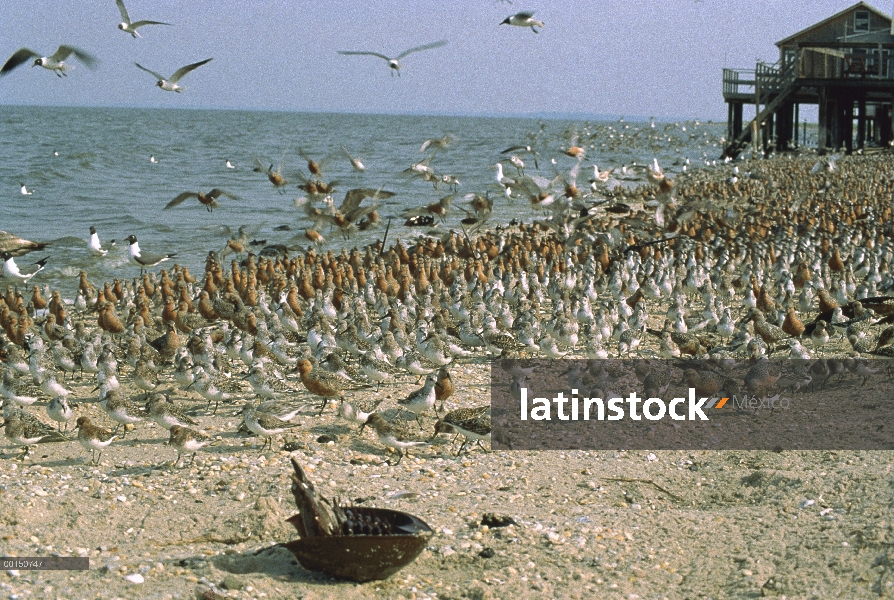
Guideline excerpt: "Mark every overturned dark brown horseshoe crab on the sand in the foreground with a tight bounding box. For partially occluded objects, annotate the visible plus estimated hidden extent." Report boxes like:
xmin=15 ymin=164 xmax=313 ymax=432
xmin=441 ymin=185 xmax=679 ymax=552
xmin=283 ymin=458 xmax=433 ymax=583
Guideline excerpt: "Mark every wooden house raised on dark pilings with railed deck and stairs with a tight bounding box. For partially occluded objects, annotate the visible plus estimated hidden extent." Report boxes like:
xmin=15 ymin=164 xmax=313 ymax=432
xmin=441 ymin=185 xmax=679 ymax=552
xmin=723 ymin=2 xmax=894 ymax=158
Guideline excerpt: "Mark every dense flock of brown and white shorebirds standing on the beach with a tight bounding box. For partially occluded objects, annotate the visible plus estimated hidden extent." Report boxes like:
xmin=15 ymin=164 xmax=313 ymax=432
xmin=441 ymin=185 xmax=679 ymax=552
xmin=0 ymin=144 xmax=894 ymax=462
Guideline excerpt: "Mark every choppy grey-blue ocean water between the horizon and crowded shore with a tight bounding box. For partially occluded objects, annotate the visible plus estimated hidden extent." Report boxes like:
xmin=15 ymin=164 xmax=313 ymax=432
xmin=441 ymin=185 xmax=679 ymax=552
xmin=0 ymin=106 xmax=725 ymax=297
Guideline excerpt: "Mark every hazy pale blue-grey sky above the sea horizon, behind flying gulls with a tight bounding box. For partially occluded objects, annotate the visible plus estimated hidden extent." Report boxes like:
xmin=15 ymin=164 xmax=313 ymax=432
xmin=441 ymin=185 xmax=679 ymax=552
xmin=0 ymin=0 xmax=894 ymax=121
